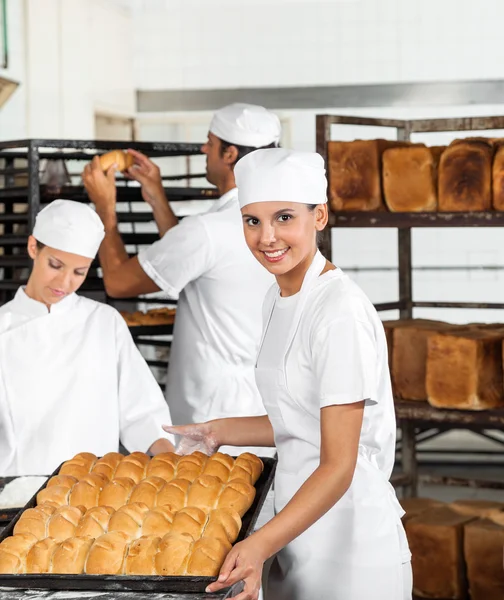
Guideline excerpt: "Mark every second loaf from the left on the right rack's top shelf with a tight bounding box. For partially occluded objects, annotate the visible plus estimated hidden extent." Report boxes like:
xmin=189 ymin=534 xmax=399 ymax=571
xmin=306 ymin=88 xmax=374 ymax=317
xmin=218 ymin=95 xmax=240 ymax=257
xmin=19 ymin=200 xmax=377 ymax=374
xmin=382 ymin=145 xmax=438 ymax=212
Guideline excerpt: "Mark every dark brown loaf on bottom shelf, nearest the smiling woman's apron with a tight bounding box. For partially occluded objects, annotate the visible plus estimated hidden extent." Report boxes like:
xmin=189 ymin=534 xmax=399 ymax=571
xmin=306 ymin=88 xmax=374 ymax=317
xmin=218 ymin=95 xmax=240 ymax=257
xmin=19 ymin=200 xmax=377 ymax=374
xmin=404 ymin=507 xmax=472 ymax=600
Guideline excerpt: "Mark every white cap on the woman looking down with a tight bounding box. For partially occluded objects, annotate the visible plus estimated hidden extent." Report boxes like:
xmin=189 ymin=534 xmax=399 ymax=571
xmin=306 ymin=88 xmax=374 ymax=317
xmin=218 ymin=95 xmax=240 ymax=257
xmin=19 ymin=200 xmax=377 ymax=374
xmin=33 ymin=200 xmax=105 ymax=258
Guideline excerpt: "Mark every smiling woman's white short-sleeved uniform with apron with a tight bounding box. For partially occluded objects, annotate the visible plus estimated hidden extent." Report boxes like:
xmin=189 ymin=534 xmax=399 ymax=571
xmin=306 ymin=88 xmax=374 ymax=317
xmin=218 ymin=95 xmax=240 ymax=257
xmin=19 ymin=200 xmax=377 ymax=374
xmin=256 ymin=255 xmax=410 ymax=600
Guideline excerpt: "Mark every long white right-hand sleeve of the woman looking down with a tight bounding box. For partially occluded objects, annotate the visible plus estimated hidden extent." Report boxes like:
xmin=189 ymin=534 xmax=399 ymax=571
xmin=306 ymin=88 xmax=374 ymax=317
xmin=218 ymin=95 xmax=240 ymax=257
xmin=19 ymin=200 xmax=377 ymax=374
xmin=116 ymin=314 xmax=174 ymax=452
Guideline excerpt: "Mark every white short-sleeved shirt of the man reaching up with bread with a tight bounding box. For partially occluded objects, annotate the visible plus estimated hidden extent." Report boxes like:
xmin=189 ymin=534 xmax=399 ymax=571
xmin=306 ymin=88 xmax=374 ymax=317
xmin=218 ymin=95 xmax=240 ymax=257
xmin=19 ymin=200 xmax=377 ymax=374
xmin=138 ymin=188 xmax=274 ymax=438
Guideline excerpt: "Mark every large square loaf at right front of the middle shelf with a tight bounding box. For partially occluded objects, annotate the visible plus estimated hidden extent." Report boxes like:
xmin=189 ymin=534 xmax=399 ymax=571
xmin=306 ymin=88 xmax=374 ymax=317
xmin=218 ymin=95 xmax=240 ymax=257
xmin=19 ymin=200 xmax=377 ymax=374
xmin=426 ymin=328 xmax=504 ymax=410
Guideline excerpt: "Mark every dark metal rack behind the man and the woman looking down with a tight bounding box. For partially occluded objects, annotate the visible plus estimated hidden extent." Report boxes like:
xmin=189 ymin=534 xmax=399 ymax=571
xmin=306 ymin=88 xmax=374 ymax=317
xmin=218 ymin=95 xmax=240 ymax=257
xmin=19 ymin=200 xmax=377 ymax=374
xmin=0 ymin=139 xmax=218 ymax=387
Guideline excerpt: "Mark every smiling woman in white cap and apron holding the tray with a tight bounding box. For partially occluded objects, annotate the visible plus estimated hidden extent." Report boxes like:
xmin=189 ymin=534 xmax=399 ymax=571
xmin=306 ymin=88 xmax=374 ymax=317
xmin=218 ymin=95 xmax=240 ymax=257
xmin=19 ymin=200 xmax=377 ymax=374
xmin=167 ymin=149 xmax=411 ymax=600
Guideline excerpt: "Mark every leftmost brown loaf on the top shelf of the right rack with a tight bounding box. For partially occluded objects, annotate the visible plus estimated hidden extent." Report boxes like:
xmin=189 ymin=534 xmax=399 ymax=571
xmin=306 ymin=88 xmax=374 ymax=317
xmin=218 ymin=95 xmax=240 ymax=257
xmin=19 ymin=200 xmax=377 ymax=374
xmin=327 ymin=140 xmax=407 ymax=211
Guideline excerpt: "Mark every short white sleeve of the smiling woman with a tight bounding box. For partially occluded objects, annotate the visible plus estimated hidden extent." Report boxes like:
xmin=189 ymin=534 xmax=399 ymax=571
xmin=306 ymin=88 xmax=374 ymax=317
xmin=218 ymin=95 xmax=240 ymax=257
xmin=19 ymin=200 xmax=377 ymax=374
xmin=312 ymin=316 xmax=378 ymax=408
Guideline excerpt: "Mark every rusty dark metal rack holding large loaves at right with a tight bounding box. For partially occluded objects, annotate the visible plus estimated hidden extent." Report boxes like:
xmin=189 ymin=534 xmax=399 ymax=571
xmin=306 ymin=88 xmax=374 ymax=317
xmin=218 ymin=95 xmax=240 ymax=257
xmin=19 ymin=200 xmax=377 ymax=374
xmin=316 ymin=115 xmax=504 ymax=496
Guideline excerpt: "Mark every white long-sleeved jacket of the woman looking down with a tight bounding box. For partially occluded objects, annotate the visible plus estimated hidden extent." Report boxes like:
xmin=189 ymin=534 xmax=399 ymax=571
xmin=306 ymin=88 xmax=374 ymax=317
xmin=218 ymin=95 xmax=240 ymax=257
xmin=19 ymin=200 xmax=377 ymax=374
xmin=0 ymin=288 xmax=171 ymax=475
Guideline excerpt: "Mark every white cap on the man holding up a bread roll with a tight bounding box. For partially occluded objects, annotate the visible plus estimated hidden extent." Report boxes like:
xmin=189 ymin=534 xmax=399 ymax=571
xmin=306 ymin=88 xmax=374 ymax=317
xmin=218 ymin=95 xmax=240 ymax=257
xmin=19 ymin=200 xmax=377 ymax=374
xmin=209 ymin=103 xmax=281 ymax=148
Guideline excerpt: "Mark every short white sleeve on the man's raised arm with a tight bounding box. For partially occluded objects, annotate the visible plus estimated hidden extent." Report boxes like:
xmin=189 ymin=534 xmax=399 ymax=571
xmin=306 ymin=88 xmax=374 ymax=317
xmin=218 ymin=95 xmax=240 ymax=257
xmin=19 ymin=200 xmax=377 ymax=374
xmin=138 ymin=217 xmax=215 ymax=299
